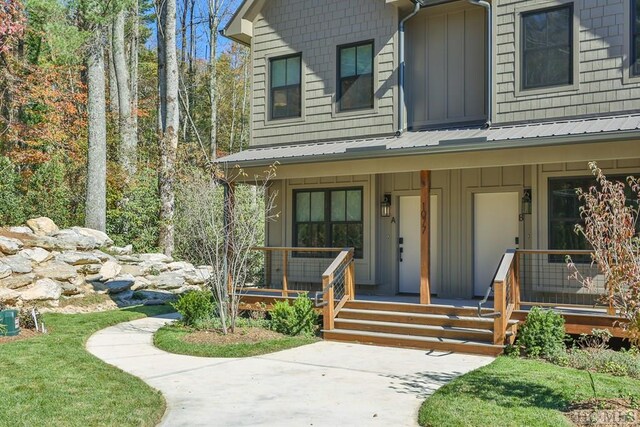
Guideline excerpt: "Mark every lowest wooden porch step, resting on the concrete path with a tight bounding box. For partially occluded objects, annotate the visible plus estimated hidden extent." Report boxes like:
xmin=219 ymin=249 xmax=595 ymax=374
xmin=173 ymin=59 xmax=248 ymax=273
xmin=323 ymin=329 xmax=504 ymax=356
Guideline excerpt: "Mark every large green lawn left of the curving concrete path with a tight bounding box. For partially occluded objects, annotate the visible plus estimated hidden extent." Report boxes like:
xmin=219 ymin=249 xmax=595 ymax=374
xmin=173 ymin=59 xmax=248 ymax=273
xmin=0 ymin=306 xmax=173 ymax=426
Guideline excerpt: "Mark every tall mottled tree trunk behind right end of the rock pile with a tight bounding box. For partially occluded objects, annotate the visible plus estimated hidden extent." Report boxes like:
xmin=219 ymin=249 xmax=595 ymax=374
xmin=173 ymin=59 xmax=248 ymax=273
xmin=159 ymin=0 xmax=180 ymax=256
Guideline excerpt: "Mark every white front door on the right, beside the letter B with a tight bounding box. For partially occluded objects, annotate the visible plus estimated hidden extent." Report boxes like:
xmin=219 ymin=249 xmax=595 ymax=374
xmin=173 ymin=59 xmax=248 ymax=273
xmin=473 ymin=192 xmax=520 ymax=296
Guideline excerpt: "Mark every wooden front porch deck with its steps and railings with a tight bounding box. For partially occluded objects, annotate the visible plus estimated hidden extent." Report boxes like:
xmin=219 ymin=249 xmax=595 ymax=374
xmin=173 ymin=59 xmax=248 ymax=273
xmin=241 ymin=248 xmax=625 ymax=356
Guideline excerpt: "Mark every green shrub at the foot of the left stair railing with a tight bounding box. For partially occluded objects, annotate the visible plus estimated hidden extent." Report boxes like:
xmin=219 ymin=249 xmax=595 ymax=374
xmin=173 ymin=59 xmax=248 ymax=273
xmin=271 ymin=293 xmax=318 ymax=336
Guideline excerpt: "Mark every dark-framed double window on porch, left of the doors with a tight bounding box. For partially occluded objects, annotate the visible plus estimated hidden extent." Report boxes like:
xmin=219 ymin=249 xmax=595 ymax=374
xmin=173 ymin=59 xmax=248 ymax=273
xmin=293 ymin=188 xmax=364 ymax=258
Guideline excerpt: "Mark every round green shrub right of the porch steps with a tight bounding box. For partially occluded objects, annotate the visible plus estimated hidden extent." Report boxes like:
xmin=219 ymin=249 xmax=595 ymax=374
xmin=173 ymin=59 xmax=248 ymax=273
xmin=518 ymin=307 xmax=565 ymax=358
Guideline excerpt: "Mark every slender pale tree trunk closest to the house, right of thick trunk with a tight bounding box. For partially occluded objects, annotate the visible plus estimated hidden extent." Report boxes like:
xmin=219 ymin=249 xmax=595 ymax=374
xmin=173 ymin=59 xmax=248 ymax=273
xmin=208 ymin=0 xmax=220 ymax=161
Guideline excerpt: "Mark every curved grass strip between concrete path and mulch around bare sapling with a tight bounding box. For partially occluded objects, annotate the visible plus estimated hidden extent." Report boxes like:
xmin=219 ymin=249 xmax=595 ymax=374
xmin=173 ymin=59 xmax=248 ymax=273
xmin=153 ymin=325 xmax=318 ymax=357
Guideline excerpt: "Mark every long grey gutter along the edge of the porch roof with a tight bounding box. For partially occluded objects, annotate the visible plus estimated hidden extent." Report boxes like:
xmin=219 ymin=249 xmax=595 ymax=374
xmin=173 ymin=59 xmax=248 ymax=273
xmin=218 ymin=131 xmax=640 ymax=168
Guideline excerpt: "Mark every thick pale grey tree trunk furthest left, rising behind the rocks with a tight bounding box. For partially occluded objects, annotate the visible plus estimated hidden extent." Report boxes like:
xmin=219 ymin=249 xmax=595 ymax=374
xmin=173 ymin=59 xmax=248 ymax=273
xmin=85 ymin=27 xmax=107 ymax=231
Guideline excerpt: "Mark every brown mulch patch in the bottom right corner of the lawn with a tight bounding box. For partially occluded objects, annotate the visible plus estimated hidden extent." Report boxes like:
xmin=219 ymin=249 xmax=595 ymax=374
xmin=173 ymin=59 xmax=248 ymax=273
xmin=566 ymin=399 xmax=640 ymax=427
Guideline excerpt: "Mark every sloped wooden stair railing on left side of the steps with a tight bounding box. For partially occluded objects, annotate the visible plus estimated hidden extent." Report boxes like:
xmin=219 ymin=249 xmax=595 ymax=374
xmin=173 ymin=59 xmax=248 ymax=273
xmin=316 ymin=248 xmax=355 ymax=331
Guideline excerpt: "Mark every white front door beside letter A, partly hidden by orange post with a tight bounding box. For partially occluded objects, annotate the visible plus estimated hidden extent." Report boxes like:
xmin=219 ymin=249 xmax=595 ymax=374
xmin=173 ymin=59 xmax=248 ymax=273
xmin=398 ymin=195 xmax=440 ymax=294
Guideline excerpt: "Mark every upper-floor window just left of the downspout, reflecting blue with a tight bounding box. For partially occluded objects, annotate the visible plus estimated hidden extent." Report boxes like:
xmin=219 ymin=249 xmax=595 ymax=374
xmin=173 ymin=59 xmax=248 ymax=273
xmin=338 ymin=41 xmax=373 ymax=111
